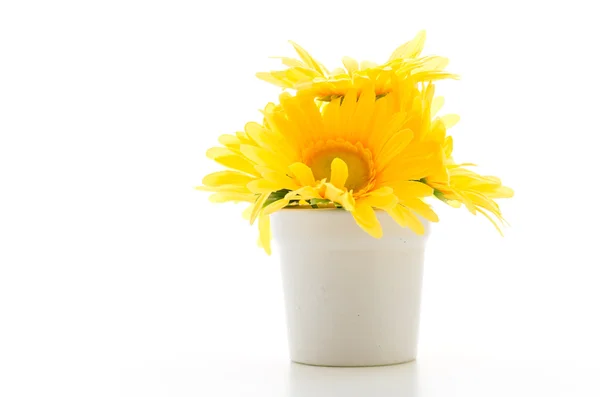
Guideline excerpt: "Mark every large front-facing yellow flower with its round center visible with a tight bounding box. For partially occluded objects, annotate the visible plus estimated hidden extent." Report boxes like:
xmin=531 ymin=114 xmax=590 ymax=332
xmin=202 ymin=85 xmax=443 ymax=252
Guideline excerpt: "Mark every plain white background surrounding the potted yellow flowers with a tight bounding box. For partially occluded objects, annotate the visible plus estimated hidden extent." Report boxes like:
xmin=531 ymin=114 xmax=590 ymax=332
xmin=0 ymin=0 xmax=600 ymax=397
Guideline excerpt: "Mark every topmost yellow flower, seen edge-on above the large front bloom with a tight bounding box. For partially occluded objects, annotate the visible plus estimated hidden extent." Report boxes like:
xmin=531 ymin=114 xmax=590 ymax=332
xmin=257 ymin=31 xmax=456 ymax=101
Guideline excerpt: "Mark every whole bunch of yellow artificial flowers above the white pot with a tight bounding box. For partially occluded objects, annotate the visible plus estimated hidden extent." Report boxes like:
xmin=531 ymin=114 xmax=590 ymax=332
xmin=199 ymin=32 xmax=513 ymax=253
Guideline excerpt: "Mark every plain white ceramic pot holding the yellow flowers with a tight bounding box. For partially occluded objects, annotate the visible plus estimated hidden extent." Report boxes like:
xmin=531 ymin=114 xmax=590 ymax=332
xmin=272 ymin=209 xmax=429 ymax=367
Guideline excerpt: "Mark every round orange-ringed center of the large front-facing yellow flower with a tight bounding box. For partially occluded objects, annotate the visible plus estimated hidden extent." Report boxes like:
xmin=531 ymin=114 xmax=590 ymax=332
xmin=302 ymin=139 xmax=375 ymax=192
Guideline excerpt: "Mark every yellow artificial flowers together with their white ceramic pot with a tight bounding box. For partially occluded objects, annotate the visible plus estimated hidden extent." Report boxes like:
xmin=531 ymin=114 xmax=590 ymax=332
xmin=199 ymin=32 xmax=513 ymax=366
